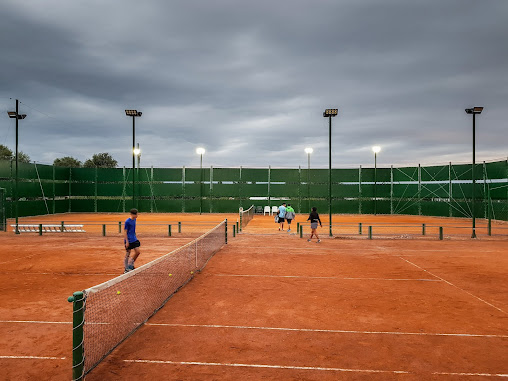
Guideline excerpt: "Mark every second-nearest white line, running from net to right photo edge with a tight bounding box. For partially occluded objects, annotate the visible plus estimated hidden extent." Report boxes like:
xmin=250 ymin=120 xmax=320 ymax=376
xmin=145 ymin=323 xmax=508 ymax=338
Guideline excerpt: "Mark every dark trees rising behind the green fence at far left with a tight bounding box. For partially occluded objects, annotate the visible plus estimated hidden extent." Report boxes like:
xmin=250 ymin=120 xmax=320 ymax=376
xmin=0 ymin=144 xmax=118 ymax=168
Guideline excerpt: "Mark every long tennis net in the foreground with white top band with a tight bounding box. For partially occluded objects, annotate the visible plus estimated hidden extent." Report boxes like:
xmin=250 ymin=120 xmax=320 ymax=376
xmin=73 ymin=220 xmax=227 ymax=379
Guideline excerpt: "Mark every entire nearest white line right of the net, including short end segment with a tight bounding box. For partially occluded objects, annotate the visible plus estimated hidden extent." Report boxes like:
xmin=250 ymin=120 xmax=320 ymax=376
xmin=123 ymin=360 xmax=508 ymax=377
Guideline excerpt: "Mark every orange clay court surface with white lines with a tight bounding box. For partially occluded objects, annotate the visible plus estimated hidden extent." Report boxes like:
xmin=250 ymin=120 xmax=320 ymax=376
xmin=0 ymin=213 xmax=508 ymax=381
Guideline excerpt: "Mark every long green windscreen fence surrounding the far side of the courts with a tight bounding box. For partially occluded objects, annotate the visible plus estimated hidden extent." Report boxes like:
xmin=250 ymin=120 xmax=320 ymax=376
xmin=0 ymin=160 xmax=508 ymax=221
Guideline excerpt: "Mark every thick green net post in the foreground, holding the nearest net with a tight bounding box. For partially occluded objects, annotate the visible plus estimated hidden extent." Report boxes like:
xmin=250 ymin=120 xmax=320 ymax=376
xmin=67 ymin=291 xmax=85 ymax=381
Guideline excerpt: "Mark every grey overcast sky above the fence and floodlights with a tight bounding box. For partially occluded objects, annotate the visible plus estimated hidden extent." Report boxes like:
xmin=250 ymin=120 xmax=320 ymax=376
xmin=0 ymin=0 xmax=508 ymax=168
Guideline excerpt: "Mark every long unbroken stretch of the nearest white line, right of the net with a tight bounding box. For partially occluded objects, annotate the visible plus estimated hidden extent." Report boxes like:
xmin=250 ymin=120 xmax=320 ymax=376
xmin=123 ymin=360 xmax=410 ymax=374
